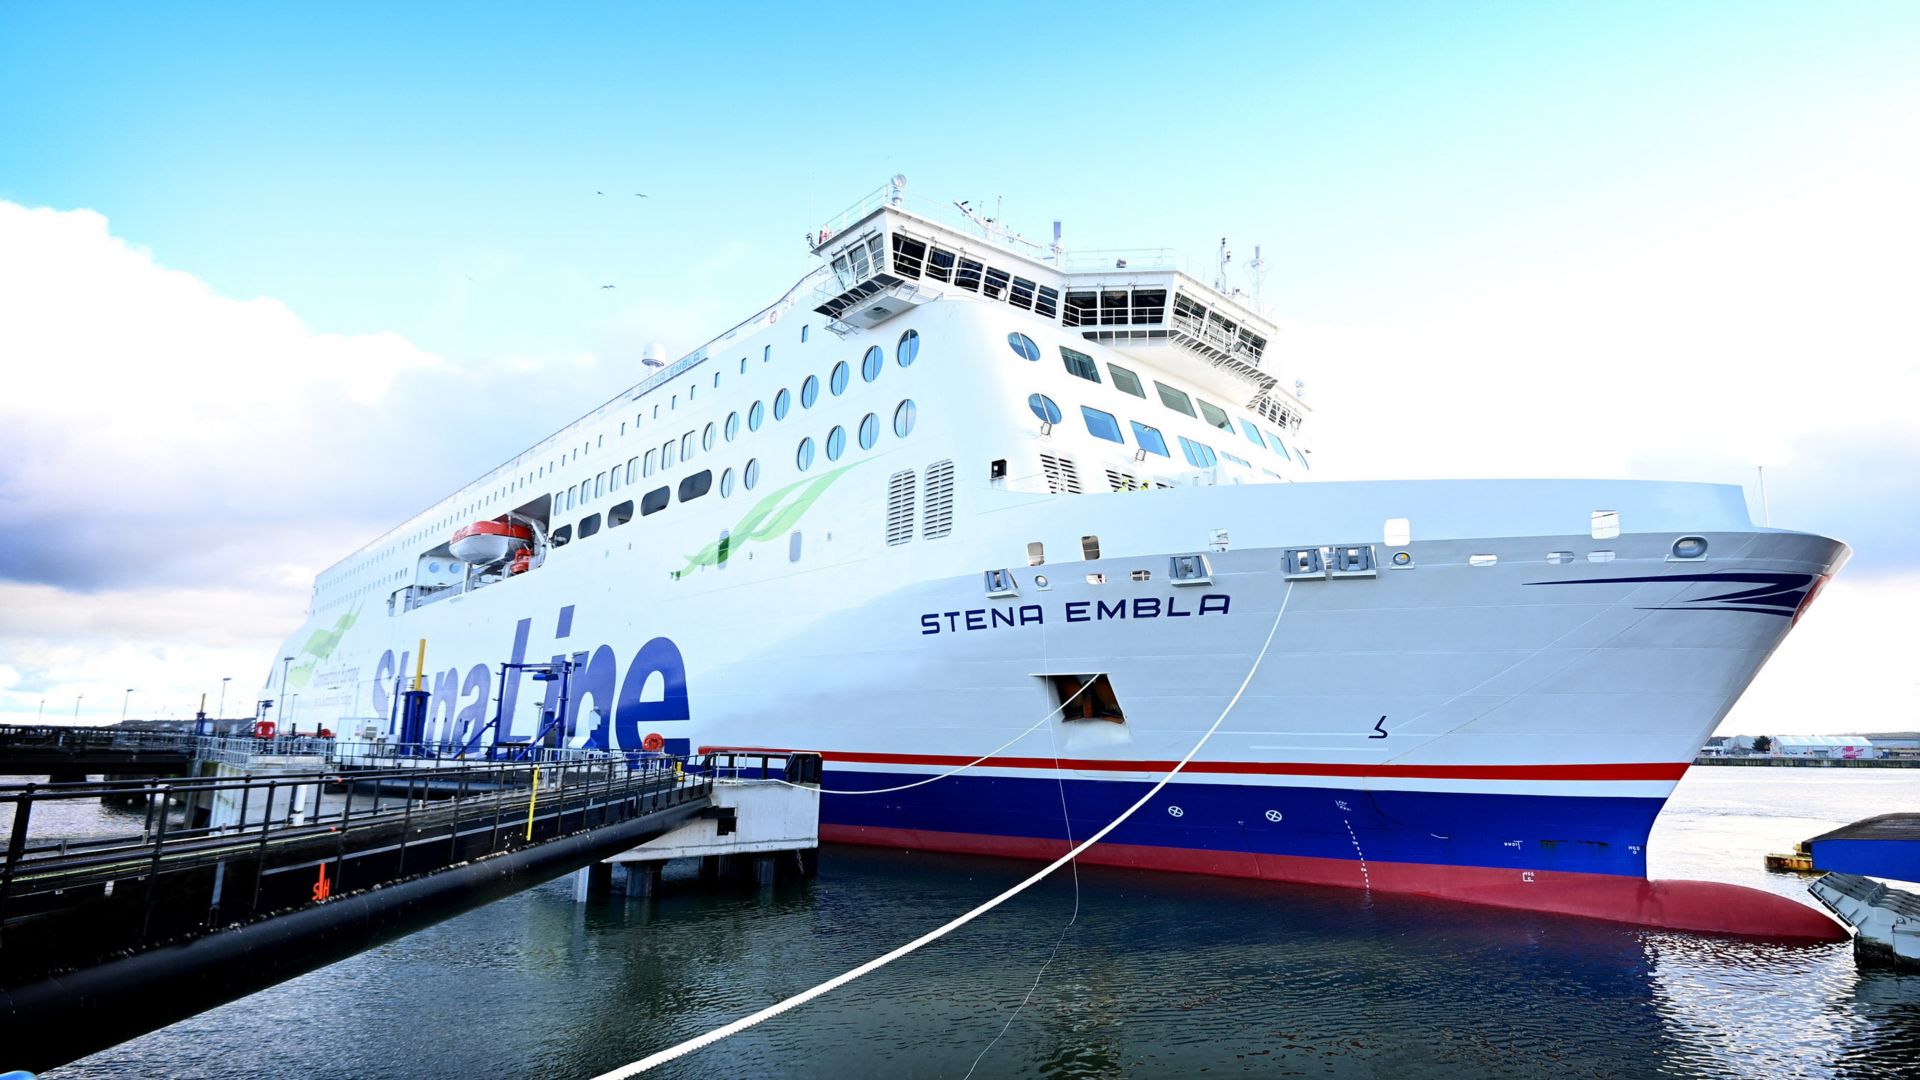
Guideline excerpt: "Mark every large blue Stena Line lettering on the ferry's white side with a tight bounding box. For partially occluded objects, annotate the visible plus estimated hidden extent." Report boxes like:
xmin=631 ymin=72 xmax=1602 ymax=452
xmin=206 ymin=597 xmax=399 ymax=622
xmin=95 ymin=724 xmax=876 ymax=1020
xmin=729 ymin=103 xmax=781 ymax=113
xmin=374 ymin=603 xmax=691 ymax=749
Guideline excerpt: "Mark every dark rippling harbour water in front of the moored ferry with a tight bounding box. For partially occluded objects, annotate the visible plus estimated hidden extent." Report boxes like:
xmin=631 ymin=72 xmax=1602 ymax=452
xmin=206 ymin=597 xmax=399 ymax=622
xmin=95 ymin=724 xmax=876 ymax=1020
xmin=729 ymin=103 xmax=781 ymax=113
xmin=33 ymin=769 xmax=1920 ymax=1080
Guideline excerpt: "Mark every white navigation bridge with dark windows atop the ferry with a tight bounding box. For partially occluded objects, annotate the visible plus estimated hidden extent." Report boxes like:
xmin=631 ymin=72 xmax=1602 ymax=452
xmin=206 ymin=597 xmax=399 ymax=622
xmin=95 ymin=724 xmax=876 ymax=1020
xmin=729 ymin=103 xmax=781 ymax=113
xmin=808 ymin=183 xmax=1306 ymax=430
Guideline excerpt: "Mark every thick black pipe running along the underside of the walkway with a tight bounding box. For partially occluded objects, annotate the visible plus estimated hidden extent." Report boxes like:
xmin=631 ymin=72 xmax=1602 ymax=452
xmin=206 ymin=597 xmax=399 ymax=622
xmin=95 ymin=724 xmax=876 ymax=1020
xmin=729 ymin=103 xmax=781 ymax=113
xmin=0 ymin=798 xmax=707 ymax=1072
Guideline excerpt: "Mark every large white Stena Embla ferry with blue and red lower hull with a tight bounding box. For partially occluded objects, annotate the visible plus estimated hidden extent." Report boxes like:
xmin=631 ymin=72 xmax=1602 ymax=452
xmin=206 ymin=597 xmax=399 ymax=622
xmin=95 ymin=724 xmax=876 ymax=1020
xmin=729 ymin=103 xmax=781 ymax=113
xmin=261 ymin=177 xmax=1847 ymax=938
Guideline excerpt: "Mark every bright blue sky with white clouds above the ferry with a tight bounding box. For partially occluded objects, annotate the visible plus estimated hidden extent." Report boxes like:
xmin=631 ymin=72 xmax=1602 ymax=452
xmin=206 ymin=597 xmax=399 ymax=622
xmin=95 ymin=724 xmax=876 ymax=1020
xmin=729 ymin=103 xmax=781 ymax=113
xmin=0 ymin=0 xmax=1920 ymax=732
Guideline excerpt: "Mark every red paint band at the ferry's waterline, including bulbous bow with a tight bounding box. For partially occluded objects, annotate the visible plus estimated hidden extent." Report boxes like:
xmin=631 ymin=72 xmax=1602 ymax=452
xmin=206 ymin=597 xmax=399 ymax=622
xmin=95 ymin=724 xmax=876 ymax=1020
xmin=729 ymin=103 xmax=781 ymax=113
xmin=820 ymin=824 xmax=1847 ymax=942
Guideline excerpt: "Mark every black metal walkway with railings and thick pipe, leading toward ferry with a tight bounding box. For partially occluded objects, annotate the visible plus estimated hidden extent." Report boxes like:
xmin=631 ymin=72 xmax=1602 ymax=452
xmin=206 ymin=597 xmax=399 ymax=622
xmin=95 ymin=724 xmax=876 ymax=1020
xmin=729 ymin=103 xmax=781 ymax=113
xmin=0 ymin=755 xmax=712 ymax=1070
